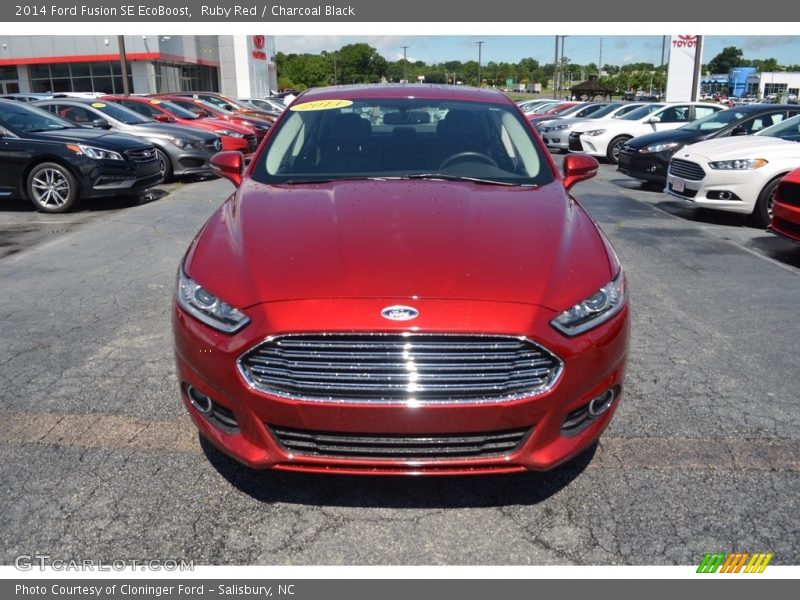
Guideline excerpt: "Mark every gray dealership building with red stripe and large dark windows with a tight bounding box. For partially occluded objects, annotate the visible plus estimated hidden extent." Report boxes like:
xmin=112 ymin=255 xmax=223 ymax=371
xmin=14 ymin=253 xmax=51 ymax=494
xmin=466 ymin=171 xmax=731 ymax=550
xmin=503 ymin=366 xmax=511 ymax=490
xmin=0 ymin=35 xmax=278 ymax=98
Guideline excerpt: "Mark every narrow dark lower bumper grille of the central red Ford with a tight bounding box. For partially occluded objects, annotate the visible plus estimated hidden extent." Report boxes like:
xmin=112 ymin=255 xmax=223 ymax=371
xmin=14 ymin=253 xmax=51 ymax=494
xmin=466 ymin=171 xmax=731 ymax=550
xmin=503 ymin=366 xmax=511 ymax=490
xmin=268 ymin=426 xmax=531 ymax=460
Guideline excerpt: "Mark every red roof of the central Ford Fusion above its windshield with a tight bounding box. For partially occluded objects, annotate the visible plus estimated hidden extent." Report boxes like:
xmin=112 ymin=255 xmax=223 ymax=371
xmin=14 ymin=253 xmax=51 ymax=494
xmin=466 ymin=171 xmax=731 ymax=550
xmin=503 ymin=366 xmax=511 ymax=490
xmin=294 ymin=83 xmax=514 ymax=105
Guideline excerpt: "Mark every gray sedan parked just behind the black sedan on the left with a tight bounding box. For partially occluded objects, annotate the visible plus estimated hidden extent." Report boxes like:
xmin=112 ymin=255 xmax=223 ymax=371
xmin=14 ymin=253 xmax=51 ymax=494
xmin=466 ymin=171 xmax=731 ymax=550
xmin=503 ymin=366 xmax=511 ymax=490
xmin=34 ymin=98 xmax=222 ymax=181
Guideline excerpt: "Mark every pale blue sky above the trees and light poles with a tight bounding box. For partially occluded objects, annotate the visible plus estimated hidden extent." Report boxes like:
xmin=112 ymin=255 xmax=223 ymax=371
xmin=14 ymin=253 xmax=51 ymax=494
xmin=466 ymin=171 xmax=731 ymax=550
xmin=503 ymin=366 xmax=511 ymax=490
xmin=275 ymin=35 xmax=800 ymax=66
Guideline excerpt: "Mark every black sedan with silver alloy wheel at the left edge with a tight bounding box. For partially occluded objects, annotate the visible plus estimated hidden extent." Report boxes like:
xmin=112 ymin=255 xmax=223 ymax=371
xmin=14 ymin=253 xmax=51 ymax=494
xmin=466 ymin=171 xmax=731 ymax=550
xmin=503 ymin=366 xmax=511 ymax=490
xmin=0 ymin=100 xmax=161 ymax=213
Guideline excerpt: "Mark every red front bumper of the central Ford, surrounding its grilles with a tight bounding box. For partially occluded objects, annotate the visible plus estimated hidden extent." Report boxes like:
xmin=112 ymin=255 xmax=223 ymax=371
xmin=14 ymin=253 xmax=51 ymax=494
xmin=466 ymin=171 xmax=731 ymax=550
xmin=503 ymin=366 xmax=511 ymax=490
xmin=173 ymin=299 xmax=629 ymax=474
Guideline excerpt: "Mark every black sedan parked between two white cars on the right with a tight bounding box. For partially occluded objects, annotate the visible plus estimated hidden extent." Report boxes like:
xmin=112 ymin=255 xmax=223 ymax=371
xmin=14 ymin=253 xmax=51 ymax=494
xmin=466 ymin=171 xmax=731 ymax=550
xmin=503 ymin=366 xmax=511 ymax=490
xmin=617 ymin=104 xmax=800 ymax=185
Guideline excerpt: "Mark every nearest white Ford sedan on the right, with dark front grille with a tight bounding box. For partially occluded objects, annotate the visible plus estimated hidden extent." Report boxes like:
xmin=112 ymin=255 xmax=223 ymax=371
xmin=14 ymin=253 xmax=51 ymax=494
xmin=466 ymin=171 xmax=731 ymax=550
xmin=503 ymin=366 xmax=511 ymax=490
xmin=664 ymin=115 xmax=800 ymax=227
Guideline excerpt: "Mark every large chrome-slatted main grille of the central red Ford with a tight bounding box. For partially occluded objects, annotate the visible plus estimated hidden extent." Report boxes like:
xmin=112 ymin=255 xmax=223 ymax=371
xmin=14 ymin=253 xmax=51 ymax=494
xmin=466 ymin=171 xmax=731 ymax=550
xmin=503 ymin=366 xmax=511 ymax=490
xmin=238 ymin=334 xmax=562 ymax=404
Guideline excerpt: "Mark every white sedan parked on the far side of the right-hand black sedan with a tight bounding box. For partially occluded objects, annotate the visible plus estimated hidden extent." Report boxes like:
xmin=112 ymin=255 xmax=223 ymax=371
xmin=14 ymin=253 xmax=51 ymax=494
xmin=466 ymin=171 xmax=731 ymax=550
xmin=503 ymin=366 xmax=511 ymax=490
xmin=569 ymin=102 xmax=724 ymax=164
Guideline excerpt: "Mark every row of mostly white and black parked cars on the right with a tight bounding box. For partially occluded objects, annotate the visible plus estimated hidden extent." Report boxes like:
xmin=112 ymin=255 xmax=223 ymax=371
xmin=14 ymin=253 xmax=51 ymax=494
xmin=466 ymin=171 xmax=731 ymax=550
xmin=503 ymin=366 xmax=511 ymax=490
xmin=536 ymin=102 xmax=800 ymax=230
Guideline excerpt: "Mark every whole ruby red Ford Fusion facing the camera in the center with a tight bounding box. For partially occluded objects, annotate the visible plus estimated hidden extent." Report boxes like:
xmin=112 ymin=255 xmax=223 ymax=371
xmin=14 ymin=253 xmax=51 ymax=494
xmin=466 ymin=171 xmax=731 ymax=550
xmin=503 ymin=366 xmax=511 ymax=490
xmin=173 ymin=85 xmax=629 ymax=475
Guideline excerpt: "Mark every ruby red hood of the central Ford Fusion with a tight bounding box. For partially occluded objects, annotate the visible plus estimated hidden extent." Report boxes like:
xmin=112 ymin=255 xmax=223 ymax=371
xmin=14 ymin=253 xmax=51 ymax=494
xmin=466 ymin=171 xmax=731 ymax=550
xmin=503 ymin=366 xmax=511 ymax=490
xmin=185 ymin=180 xmax=617 ymax=311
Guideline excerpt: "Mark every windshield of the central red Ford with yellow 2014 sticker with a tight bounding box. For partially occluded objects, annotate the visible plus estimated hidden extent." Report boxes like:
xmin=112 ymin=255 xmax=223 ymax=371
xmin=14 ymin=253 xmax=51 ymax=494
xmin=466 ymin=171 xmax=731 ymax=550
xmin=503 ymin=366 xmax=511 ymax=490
xmin=253 ymin=98 xmax=553 ymax=185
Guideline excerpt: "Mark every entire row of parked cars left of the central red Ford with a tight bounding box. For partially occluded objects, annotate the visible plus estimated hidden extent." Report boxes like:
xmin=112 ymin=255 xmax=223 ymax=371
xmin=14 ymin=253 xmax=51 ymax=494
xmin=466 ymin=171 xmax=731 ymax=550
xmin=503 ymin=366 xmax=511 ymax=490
xmin=0 ymin=92 xmax=286 ymax=213
